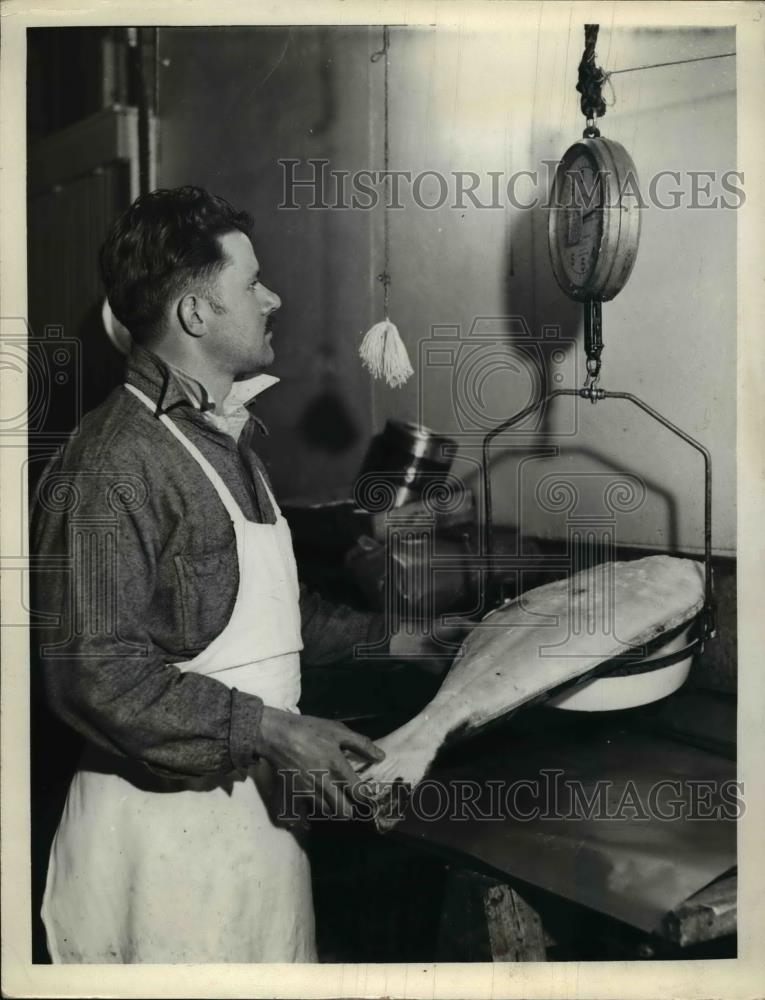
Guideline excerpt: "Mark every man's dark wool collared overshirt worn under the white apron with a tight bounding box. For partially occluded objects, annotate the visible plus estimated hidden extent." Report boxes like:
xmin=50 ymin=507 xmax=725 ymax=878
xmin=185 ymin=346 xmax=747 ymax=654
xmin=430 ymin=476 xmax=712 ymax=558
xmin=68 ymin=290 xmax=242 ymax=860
xmin=31 ymin=348 xmax=384 ymax=777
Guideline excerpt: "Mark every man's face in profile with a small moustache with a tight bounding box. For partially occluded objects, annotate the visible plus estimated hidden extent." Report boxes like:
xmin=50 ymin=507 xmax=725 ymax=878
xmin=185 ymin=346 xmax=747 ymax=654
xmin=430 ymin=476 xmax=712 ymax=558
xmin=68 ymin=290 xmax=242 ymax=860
xmin=204 ymin=230 xmax=282 ymax=378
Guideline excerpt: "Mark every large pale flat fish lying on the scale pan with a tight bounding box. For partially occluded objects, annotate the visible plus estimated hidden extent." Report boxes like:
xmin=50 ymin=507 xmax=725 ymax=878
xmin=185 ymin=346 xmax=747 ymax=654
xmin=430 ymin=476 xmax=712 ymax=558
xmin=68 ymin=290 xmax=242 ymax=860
xmin=363 ymin=556 xmax=704 ymax=830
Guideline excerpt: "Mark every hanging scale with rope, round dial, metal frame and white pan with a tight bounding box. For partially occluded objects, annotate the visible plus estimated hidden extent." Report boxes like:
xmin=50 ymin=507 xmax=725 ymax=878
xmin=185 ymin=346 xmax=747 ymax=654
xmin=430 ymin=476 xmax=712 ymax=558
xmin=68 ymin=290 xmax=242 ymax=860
xmin=496 ymin=31 xmax=715 ymax=711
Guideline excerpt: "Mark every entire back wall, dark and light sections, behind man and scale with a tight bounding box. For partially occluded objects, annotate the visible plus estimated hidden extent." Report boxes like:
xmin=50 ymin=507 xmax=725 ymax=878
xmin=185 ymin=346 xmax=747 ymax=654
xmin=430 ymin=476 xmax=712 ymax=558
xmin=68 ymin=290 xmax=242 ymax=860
xmin=155 ymin=21 xmax=736 ymax=552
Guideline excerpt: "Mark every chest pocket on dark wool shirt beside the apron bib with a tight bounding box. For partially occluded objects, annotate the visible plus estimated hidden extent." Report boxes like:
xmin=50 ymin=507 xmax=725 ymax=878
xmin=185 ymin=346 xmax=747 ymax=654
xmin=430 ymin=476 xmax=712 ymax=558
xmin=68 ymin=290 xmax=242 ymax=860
xmin=174 ymin=539 xmax=239 ymax=653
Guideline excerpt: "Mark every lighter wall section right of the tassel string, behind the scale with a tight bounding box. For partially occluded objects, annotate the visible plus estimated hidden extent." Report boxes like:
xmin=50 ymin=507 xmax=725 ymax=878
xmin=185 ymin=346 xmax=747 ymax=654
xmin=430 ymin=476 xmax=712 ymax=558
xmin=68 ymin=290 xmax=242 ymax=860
xmin=376 ymin=21 xmax=736 ymax=551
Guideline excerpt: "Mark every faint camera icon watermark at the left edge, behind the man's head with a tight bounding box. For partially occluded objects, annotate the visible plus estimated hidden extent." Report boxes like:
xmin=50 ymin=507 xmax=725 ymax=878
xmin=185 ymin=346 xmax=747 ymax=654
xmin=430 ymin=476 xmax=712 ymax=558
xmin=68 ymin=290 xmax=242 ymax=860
xmin=0 ymin=317 xmax=82 ymax=447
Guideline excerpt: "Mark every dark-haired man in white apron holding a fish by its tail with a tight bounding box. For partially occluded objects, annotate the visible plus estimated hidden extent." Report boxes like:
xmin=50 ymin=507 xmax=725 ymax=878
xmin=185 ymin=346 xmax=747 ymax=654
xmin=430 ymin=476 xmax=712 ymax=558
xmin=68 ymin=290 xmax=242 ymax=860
xmin=32 ymin=187 xmax=424 ymax=962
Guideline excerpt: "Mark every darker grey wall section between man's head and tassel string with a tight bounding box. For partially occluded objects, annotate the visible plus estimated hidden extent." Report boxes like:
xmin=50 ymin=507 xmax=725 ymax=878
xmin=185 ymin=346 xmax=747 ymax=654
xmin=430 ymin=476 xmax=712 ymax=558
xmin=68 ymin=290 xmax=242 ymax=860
xmin=159 ymin=28 xmax=374 ymax=500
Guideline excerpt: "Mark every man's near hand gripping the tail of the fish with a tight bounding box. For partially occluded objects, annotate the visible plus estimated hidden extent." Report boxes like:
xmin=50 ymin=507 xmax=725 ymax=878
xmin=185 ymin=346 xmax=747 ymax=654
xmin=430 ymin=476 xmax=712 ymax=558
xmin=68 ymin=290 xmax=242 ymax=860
xmin=255 ymin=705 xmax=385 ymax=816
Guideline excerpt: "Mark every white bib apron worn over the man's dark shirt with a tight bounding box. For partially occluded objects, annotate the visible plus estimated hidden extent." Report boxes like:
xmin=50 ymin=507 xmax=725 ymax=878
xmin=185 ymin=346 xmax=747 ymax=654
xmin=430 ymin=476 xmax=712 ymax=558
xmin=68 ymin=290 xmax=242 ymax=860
xmin=42 ymin=385 xmax=316 ymax=963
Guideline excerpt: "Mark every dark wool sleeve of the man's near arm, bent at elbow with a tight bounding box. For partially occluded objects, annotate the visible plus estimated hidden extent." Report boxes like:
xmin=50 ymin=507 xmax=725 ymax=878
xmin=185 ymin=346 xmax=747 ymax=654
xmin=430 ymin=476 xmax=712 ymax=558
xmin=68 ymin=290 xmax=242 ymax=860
xmin=31 ymin=458 xmax=263 ymax=778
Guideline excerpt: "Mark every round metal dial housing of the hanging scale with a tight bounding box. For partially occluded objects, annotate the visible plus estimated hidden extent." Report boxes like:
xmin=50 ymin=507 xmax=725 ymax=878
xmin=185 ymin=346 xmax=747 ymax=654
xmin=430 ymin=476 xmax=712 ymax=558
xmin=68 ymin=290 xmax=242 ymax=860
xmin=548 ymin=138 xmax=640 ymax=301
